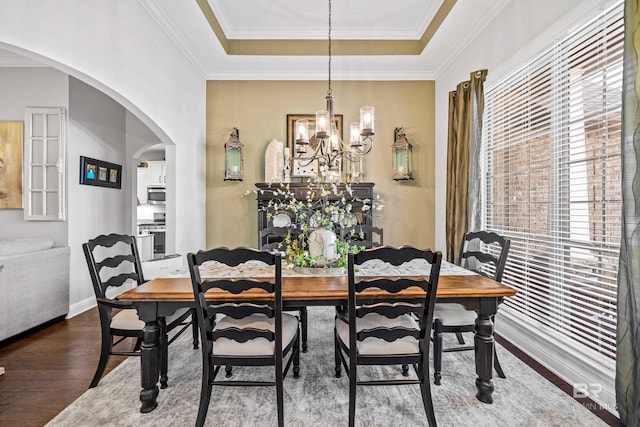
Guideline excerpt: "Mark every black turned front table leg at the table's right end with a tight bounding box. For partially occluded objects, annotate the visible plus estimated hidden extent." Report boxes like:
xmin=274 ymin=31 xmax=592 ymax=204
xmin=474 ymin=304 xmax=495 ymax=403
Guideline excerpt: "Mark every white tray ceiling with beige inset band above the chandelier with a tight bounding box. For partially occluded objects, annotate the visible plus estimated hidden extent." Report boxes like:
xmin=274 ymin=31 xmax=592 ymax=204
xmin=0 ymin=0 xmax=510 ymax=80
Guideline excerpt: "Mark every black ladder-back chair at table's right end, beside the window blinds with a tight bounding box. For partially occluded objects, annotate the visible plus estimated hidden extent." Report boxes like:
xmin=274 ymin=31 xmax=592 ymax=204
xmin=433 ymin=231 xmax=511 ymax=385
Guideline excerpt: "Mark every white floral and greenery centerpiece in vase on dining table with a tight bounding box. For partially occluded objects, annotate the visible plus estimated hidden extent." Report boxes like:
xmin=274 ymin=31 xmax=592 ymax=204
xmin=259 ymin=171 xmax=384 ymax=269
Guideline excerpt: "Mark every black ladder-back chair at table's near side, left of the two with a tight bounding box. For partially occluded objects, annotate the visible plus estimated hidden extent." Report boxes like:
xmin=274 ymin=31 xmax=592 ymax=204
xmin=187 ymin=248 xmax=300 ymax=426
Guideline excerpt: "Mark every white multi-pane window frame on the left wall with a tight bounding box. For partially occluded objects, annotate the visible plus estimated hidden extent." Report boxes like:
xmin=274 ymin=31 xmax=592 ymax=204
xmin=23 ymin=107 xmax=66 ymax=221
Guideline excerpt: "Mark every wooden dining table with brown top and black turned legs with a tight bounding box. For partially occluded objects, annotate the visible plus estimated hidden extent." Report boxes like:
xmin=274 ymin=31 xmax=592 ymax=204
xmin=118 ymin=274 xmax=516 ymax=412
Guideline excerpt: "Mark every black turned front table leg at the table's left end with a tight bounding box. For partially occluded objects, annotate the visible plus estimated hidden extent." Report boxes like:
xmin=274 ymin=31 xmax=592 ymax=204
xmin=138 ymin=310 xmax=160 ymax=413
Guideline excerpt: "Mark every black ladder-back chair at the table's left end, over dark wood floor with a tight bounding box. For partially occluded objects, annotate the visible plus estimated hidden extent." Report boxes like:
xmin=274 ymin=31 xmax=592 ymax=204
xmin=82 ymin=234 xmax=198 ymax=388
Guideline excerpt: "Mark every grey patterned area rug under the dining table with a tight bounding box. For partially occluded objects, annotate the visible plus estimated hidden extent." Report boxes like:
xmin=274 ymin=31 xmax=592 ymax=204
xmin=47 ymin=307 xmax=606 ymax=427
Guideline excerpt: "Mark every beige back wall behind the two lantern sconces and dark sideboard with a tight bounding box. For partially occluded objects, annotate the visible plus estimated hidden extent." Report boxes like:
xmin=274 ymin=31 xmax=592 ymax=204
xmin=206 ymin=81 xmax=436 ymax=248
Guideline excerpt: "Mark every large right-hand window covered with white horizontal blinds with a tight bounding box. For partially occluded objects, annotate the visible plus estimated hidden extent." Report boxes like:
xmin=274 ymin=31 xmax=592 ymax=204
xmin=481 ymin=1 xmax=624 ymax=406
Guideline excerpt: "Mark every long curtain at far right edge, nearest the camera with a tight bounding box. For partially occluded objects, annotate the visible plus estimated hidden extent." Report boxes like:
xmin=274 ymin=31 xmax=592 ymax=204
xmin=616 ymin=0 xmax=640 ymax=426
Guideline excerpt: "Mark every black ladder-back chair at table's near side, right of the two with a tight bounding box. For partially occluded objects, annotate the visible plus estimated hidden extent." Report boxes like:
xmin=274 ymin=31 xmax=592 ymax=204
xmin=334 ymin=246 xmax=442 ymax=427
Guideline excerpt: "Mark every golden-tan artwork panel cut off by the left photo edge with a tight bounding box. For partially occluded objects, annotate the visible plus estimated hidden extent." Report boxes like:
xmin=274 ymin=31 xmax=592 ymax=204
xmin=0 ymin=122 xmax=24 ymax=209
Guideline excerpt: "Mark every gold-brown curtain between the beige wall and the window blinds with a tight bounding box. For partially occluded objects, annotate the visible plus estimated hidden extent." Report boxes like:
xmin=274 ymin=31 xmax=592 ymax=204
xmin=446 ymin=70 xmax=487 ymax=263
